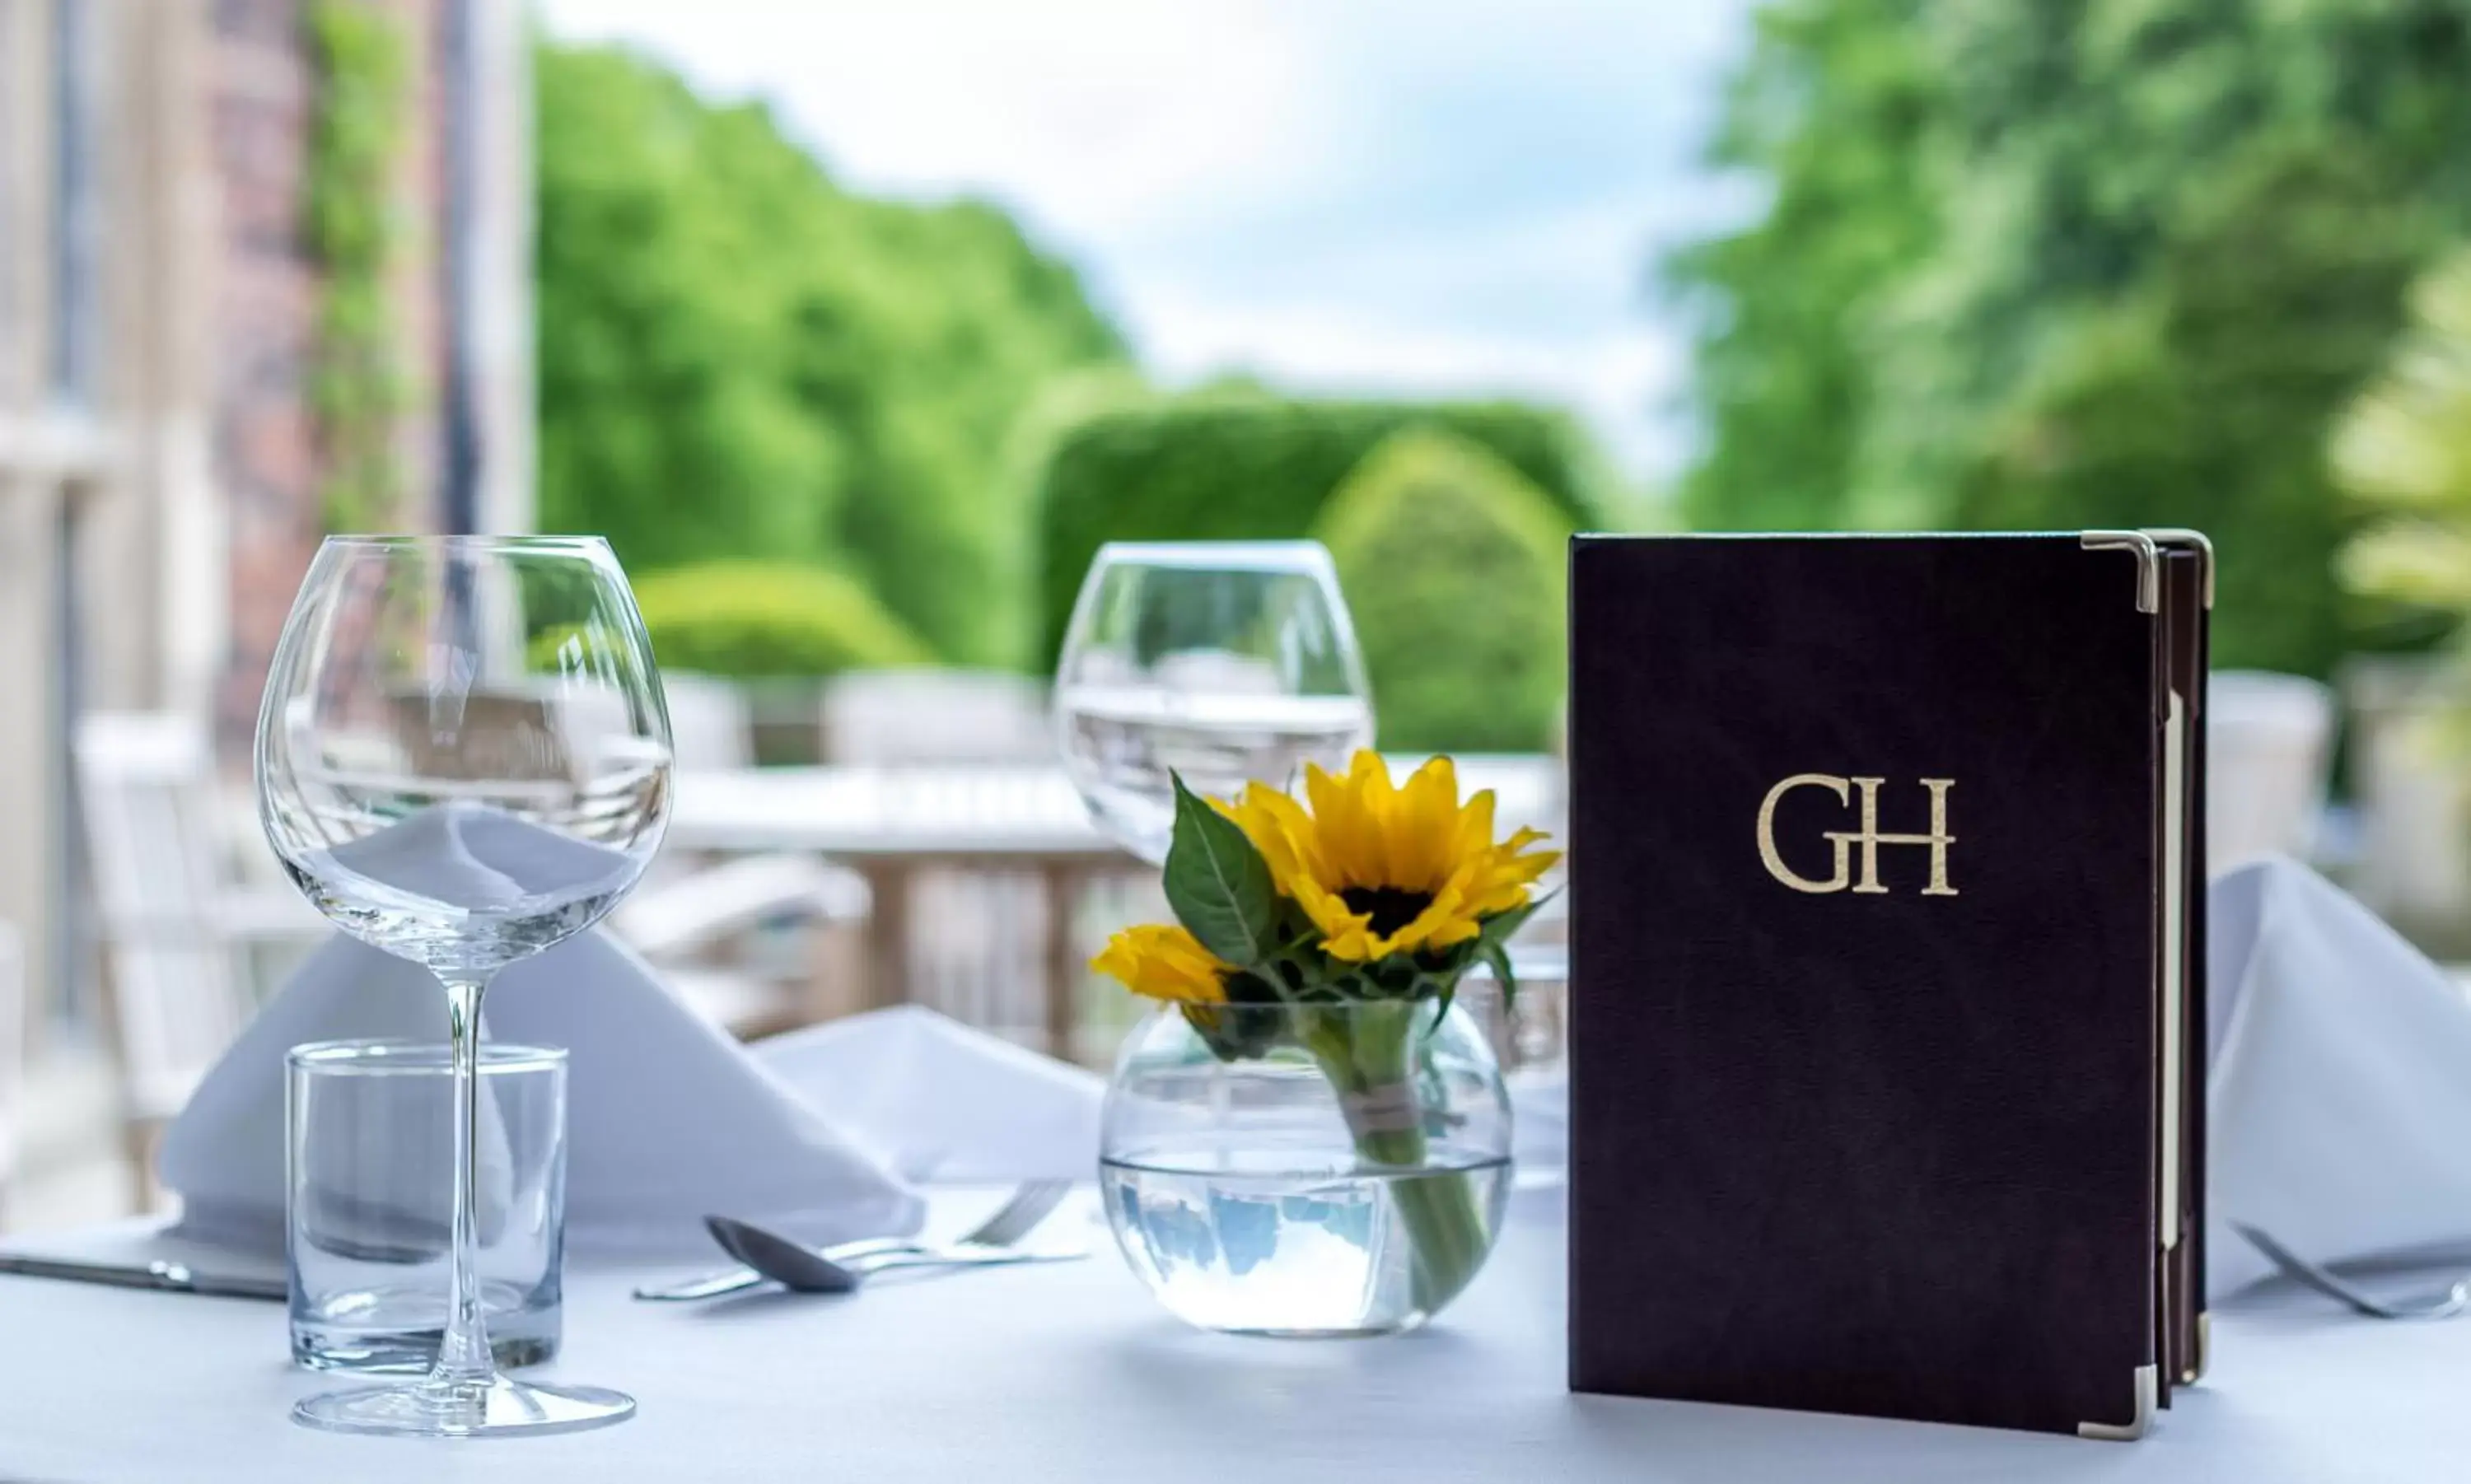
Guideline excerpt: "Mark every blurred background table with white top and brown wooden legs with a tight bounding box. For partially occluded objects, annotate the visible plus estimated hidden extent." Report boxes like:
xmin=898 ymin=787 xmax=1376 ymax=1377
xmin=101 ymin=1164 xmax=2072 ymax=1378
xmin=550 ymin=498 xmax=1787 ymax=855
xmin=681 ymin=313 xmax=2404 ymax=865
xmin=667 ymin=753 xmax=1557 ymax=1022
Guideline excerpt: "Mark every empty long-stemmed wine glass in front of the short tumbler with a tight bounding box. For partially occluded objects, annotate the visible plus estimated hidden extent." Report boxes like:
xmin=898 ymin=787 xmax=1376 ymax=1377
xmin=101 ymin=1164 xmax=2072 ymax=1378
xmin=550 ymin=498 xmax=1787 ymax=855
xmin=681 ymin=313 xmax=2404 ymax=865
xmin=257 ymin=536 xmax=670 ymax=1437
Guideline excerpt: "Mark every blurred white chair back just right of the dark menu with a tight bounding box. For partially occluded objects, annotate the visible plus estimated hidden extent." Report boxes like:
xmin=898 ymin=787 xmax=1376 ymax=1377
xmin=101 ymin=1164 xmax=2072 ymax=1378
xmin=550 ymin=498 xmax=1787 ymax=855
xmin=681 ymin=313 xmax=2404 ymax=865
xmin=2204 ymin=670 xmax=2335 ymax=874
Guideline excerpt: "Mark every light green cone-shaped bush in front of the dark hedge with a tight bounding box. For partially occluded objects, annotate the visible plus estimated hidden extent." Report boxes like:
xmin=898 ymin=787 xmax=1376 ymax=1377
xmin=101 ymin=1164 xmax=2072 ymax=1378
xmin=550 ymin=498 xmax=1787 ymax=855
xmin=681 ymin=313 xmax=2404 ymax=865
xmin=1320 ymin=430 xmax=1572 ymax=753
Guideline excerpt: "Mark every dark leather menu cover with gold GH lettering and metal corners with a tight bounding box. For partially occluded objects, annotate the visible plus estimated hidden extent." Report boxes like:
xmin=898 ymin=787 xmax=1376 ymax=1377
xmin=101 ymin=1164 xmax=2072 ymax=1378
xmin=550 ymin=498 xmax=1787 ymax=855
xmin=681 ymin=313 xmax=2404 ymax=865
xmin=1569 ymin=534 xmax=2202 ymax=1437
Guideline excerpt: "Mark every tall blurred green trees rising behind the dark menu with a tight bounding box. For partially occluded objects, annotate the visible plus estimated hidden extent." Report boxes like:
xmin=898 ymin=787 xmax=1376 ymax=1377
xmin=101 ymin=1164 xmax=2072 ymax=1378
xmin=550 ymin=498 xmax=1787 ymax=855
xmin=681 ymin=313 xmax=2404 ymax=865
xmin=1668 ymin=0 xmax=2471 ymax=672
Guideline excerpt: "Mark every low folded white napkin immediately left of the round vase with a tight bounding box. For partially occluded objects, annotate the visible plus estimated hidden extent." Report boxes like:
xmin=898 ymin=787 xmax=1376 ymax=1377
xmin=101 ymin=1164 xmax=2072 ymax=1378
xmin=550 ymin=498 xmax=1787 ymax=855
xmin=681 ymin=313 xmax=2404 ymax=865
xmin=754 ymin=1005 xmax=1107 ymax=1183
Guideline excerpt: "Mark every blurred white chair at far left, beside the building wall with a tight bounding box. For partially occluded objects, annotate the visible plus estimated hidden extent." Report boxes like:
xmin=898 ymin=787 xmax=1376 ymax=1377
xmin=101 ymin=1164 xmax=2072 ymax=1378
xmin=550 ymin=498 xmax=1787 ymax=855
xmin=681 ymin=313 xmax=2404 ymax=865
xmin=72 ymin=712 xmax=331 ymax=1205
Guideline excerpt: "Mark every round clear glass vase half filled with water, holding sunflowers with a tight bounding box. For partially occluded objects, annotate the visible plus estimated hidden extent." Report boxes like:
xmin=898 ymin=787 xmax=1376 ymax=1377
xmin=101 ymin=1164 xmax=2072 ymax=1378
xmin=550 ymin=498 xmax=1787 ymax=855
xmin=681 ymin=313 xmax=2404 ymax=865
xmin=1100 ymin=1000 xmax=1510 ymax=1336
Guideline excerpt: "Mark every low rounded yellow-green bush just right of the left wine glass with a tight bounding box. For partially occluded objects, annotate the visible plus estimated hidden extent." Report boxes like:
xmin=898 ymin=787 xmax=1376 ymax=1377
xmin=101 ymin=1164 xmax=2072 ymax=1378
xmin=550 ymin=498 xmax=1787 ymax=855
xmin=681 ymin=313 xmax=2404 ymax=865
xmin=534 ymin=561 xmax=929 ymax=679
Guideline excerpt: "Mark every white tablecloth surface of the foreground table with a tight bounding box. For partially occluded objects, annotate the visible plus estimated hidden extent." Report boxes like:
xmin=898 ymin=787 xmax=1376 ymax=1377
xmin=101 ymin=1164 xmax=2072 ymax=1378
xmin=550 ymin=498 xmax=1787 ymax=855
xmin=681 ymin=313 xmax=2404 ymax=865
xmin=0 ymin=1190 xmax=2471 ymax=1484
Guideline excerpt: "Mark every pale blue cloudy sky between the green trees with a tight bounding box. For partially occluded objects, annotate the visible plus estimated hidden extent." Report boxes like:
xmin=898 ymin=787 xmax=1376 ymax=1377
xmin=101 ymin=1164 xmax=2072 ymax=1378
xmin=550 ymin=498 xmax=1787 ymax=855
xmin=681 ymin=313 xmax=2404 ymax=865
xmin=539 ymin=0 xmax=1749 ymax=482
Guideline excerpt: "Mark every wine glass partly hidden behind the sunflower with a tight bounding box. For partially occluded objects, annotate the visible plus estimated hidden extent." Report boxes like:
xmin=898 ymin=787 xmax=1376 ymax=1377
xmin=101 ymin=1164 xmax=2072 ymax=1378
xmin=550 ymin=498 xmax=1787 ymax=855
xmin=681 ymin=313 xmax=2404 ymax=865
xmin=1055 ymin=541 xmax=1374 ymax=864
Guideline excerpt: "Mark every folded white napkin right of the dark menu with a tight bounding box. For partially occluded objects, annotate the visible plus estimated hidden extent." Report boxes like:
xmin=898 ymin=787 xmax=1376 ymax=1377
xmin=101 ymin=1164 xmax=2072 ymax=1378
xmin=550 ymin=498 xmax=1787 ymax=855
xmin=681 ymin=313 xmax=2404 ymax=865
xmin=2207 ymin=856 xmax=2471 ymax=1296
